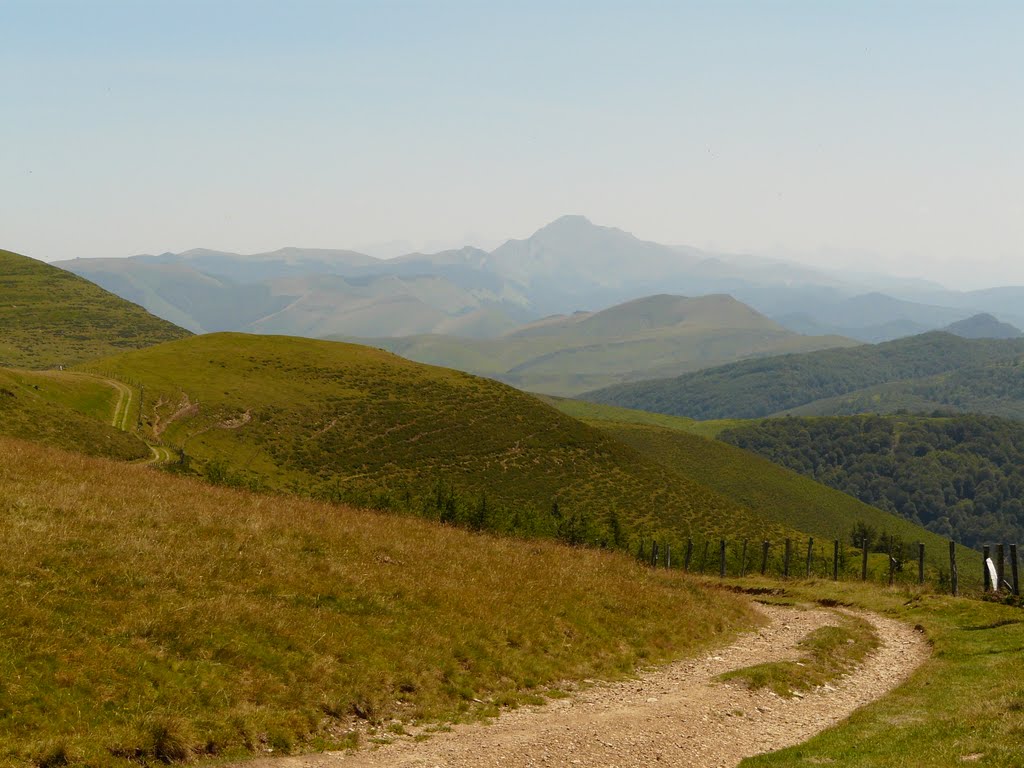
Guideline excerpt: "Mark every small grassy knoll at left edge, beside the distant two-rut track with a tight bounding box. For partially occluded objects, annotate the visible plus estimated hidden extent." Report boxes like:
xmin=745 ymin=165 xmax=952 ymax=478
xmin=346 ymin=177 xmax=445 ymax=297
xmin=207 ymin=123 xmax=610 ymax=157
xmin=0 ymin=369 xmax=150 ymax=461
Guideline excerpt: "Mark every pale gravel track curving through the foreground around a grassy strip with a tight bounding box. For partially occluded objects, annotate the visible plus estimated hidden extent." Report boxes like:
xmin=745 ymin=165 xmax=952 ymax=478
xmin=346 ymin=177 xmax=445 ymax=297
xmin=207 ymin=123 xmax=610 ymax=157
xmin=237 ymin=606 xmax=929 ymax=768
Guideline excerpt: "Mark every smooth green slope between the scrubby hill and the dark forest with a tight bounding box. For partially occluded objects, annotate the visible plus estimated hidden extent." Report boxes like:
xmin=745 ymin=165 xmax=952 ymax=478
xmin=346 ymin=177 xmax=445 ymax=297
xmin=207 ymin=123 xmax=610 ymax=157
xmin=555 ymin=400 xmax=970 ymax=571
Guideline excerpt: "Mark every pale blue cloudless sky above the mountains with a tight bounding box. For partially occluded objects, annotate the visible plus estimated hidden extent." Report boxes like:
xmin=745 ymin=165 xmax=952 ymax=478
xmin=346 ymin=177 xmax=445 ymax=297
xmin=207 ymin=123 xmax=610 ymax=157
xmin=0 ymin=0 xmax=1024 ymax=288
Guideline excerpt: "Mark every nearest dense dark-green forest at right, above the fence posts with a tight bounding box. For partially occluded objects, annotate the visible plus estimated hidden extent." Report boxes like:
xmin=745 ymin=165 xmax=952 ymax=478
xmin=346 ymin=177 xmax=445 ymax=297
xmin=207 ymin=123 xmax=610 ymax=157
xmin=720 ymin=415 xmax=1024 ymax=547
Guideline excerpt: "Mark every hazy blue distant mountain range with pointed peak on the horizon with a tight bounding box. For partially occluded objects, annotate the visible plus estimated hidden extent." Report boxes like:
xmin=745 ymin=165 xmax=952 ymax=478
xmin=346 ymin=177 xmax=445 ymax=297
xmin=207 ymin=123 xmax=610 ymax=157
xmin=56 ymin=216 xmax=1024 ymax=342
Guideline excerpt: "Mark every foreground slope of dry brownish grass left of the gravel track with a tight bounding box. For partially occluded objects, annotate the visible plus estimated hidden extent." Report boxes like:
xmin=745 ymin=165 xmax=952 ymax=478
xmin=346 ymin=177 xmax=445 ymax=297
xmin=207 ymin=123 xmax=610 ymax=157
xmin=0 ymin=438 xmax=754 ymax=768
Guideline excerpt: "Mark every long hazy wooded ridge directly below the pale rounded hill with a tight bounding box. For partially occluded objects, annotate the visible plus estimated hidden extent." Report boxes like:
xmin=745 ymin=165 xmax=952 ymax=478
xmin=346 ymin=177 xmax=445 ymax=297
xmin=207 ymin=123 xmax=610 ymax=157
xmin=583 ymin=332 xmax=1024 ymax=419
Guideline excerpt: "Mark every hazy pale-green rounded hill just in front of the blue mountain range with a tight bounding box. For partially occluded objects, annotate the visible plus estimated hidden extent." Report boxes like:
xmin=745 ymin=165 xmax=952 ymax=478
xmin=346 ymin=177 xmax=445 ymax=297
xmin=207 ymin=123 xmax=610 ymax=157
xmin=339 ymin=295 xmax=854 ymax=394
